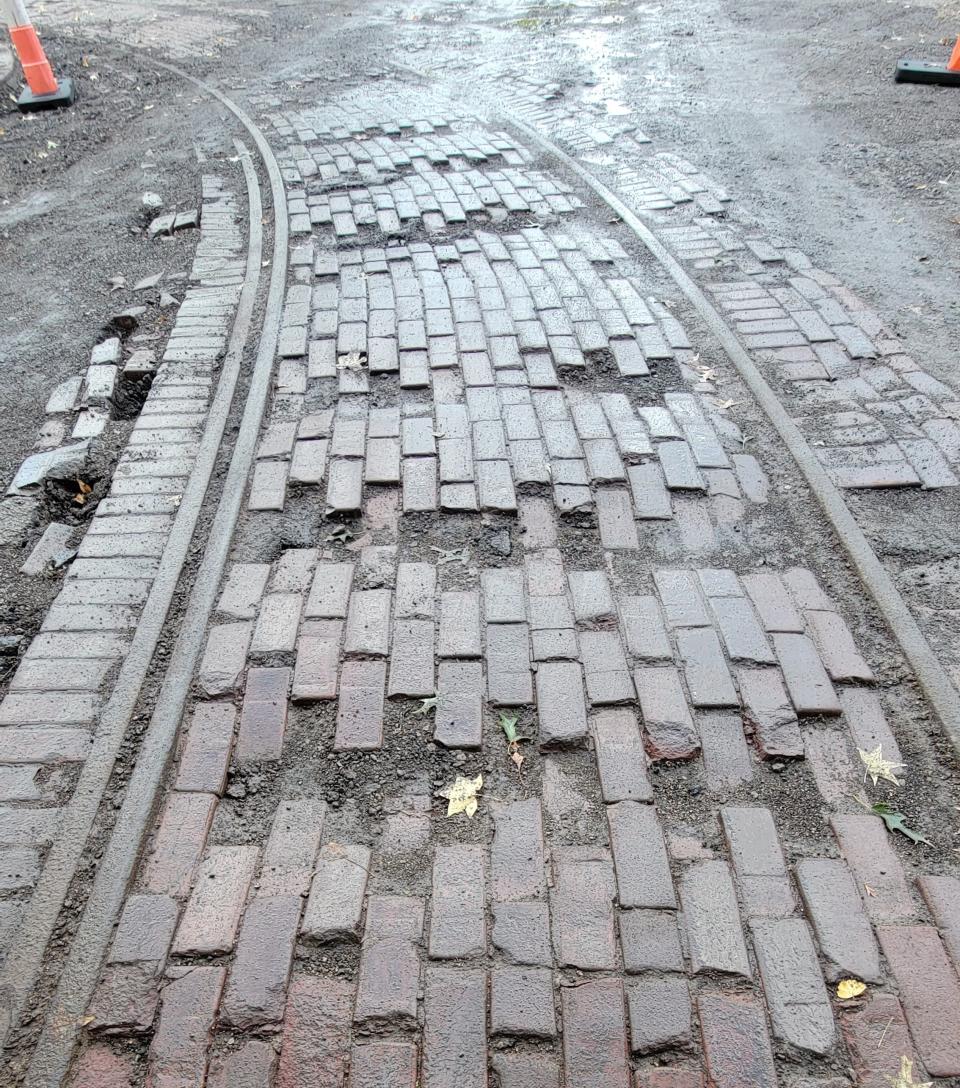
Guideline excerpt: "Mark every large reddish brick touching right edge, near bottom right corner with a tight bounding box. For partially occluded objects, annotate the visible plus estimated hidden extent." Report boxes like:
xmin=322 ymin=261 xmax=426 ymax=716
xmin=876 ymin=926 xmax=960 ymax=1077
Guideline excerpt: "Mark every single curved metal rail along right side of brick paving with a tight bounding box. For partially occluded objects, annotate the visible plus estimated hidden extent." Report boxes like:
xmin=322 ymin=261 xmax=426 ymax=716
xmin=500 ymin=110 xmax=960 ymax=754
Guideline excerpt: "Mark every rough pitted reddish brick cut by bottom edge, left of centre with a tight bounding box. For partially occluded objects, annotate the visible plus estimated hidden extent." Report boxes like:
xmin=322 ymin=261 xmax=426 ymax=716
xmin=274 ymin=975 xmax=353 ymax=1088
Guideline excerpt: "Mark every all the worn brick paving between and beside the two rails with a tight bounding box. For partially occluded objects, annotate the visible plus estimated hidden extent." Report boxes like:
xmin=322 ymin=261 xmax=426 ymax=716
xmin=0 ymin=5 xmax=960 ymax=1088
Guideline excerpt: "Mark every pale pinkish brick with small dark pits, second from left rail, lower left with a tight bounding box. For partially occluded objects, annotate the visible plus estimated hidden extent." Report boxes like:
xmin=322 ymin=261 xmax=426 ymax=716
xmin=173 ymin=846 xmax=260 ymax=955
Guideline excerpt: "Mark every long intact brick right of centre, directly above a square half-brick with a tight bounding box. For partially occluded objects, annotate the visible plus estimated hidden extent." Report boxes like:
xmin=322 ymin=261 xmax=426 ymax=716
xmin=606 ymin=801 xmax=677 ymax=908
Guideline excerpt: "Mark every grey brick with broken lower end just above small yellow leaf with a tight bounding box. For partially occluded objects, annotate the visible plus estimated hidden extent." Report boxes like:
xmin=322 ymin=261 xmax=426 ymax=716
xmin=797 ymin=857 xmax=883 ymax=982
